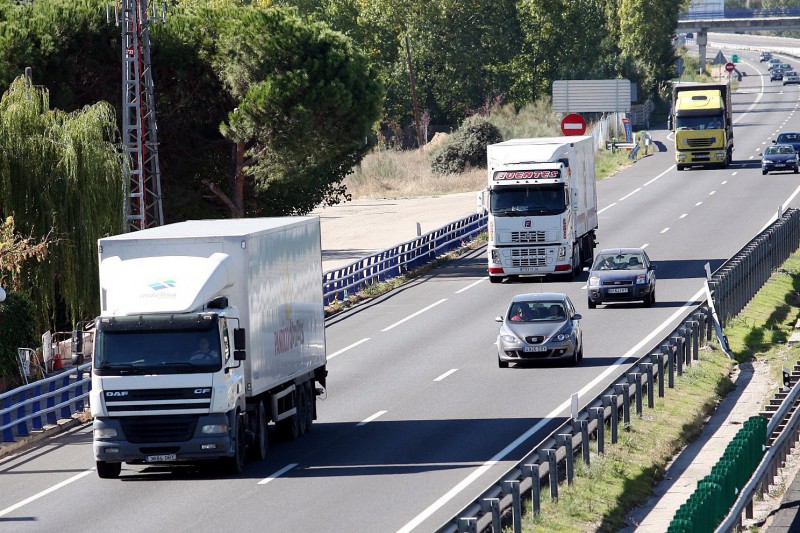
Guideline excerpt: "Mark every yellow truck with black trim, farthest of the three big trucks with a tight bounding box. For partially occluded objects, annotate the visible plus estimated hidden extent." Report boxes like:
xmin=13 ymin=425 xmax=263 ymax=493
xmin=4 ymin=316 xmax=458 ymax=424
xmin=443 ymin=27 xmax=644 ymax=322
xmin=668 ymin=83 xmax=733 ymax=170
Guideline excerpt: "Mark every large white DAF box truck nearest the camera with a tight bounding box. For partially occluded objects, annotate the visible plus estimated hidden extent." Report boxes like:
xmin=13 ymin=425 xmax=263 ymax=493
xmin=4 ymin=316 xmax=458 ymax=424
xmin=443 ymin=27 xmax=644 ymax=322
xmin=86 ymin=217 xmax=327 ymax=478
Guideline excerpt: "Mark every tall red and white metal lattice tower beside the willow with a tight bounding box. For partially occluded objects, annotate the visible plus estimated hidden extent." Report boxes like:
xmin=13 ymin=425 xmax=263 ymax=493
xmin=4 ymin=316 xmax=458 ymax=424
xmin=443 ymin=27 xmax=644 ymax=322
xmin=118 ymin=0 xmax=166 ymax=231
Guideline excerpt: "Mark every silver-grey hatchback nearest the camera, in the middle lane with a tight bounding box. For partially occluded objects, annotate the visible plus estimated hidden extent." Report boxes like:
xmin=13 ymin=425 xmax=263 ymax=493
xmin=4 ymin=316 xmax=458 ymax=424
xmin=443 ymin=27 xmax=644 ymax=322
xmin=495 ymin=292 xmax=583 ymax=368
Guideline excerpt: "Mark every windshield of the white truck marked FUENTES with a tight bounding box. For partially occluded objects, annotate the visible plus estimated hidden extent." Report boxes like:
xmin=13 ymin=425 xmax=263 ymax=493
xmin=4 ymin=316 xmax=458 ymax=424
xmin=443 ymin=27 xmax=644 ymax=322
xmin=490 ymin=183 xmax=567 ymax=217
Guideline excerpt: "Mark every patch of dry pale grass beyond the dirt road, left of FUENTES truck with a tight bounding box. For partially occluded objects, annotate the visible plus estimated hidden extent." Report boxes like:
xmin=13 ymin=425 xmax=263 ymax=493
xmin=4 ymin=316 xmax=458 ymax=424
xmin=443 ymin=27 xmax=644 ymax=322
xmin=344 ymin=149 xmax=486 ymax=199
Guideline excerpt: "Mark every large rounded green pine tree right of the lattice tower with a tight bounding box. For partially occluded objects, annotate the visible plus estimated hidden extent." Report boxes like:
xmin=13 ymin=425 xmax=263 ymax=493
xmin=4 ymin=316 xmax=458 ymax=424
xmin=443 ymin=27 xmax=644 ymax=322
xmin=202 ymin=8 xmax=383 ymax=217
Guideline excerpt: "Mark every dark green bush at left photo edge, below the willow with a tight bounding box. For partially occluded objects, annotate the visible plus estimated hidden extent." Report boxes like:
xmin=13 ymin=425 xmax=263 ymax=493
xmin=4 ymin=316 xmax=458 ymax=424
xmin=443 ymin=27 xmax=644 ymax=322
xmin=0 ymin=293 xmax=37 ymax=383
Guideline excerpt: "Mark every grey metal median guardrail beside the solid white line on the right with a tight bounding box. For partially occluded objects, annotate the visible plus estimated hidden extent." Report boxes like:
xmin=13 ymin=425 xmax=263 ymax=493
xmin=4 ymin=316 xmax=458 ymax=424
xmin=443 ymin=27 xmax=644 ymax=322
xmin=437 ymin=209 xmax=800 ymax=533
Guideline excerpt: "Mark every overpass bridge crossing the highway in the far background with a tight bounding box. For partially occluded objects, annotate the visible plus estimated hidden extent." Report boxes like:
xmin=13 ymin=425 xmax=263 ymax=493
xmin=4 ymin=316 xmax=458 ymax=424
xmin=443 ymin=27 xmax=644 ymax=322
xmin=675 ymin=8 xmax=800 ymax=70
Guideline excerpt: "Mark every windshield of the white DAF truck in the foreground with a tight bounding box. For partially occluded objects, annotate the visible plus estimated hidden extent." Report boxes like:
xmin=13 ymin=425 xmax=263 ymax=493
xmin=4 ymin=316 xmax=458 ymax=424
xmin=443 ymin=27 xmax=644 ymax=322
xmin=94 ymin=328 xmax=222 ymax=375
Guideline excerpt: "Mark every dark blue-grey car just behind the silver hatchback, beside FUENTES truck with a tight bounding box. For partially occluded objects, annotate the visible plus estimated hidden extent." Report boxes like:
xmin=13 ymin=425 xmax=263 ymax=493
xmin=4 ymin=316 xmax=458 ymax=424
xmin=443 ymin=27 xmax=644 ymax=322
xmin=587 ymin=248 xmax=656 ymax=309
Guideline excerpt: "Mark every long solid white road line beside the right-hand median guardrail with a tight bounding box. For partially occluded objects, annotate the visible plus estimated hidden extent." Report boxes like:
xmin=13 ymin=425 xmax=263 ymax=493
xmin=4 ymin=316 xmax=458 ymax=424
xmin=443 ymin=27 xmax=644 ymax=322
xmin=397 ymin=287 xmax=706 ymax=533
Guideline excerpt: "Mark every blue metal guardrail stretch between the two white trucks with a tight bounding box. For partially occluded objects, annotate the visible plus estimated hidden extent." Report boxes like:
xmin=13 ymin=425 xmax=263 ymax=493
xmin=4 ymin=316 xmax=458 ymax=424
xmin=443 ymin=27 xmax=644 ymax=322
xmin=322 ymin=214 xmax=487 ymax=305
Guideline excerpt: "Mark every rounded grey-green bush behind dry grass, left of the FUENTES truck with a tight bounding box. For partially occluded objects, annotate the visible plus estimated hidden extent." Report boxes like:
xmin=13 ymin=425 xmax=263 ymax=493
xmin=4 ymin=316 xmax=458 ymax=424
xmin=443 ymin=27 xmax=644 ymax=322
xmin=431 ymin=116 xmax=503 ymax=174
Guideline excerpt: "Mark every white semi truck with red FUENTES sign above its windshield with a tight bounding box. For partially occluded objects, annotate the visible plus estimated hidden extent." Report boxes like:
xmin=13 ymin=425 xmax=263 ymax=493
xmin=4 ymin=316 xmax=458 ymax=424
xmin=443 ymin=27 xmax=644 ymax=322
xmin=478 ymin=136 xmax=597 ymax=283
